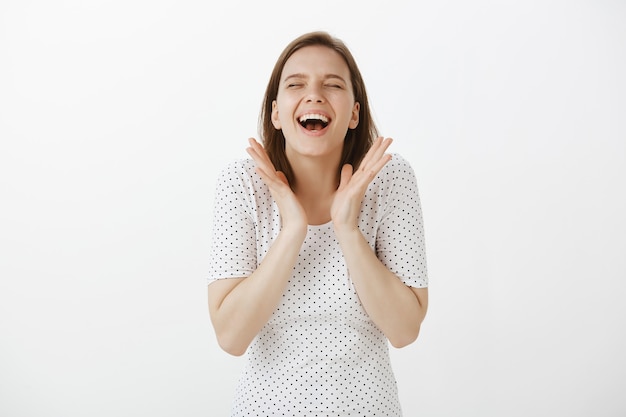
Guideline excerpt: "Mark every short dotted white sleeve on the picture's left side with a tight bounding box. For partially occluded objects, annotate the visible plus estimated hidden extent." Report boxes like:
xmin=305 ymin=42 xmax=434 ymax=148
xmin=207 ymin=161 xmax=257 ymax=283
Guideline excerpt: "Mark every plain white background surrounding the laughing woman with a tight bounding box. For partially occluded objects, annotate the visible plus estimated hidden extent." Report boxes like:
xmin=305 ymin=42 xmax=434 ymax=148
xmin=0 ymin=0 xmax=626 ymax=417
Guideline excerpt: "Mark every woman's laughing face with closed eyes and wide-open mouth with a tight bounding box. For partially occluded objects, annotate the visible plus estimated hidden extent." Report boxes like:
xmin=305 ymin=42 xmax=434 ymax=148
xmin=272 ymin=46 xmax=360 ymax=161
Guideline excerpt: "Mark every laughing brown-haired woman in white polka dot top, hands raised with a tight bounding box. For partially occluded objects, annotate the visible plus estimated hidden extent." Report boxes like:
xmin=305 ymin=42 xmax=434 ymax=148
xmin=208 ymin=32 xmax=428 ymax=416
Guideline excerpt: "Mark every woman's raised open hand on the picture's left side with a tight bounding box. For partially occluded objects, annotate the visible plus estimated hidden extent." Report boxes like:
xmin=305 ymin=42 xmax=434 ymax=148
xmin=246 ymin=138 xmax=308 ymax=235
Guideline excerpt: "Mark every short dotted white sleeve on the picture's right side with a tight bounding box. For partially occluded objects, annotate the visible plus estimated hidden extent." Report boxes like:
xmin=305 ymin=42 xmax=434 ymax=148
xmin=376 ymin=154 xmax=428 ymax=288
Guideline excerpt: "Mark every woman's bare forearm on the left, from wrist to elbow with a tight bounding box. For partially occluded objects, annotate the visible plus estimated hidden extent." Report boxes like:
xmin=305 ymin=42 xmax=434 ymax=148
xmin=211 ymin=224 xmax=304 ymax=355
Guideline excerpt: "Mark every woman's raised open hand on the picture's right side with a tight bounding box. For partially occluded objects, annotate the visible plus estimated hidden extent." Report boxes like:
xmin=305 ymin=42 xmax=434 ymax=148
xmin=330 ymin=137 xmax=393 ymax=232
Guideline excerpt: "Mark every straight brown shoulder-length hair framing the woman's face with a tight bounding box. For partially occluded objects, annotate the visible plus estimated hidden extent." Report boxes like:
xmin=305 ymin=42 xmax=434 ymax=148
xmin=259 ymin=32 xmax=378 ymax=186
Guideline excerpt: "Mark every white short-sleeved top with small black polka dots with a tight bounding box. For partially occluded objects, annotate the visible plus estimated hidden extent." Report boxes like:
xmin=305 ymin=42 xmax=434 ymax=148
xmin=208 ymin=154 xmax=428 ymax=417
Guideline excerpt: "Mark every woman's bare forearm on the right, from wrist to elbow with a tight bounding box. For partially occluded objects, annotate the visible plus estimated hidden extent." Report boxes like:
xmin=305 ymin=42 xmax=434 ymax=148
xmin=337 ymin=229 xmax=427 ymax=347
